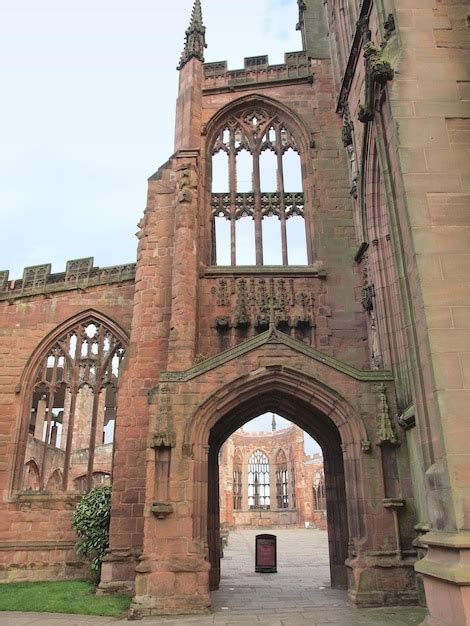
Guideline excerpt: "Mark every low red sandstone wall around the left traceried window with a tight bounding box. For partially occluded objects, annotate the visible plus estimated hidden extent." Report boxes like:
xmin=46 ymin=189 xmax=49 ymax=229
xmin=0 ymin=264 xmax=134 ymax=581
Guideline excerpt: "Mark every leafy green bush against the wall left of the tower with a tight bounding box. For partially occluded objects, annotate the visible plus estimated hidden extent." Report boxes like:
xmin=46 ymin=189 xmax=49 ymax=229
xmin=72 ymin=487 xmax=111 ymax=579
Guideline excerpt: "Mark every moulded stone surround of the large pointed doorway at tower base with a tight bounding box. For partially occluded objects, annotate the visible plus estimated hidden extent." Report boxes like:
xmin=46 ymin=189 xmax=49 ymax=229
xmin=188 ymin=367 xmax=365 ymax=589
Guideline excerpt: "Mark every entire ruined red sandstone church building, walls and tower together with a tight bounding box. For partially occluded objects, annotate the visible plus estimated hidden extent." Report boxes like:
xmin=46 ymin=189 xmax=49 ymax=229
xmin=0 ymin=0 xmax=470 ymax=626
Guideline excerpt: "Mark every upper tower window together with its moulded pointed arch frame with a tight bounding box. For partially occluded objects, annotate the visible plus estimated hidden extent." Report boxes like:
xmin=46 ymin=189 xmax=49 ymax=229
xmin=205 ymin=94 xmax=314 ymax=266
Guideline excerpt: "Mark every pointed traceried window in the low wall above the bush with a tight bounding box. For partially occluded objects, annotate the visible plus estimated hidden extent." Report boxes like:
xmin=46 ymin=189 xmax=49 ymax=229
xmin=22 ymin=317 xmax=124 ymax=492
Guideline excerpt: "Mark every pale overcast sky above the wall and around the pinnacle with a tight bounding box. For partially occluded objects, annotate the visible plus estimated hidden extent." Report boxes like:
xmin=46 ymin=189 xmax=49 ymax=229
xmin=0 ymin=0 xmax=301 ymax=278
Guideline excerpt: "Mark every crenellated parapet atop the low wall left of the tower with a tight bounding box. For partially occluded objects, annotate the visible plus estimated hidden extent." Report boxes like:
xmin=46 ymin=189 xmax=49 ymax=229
xmin=0 ymin=257 xmax=135 ymax=300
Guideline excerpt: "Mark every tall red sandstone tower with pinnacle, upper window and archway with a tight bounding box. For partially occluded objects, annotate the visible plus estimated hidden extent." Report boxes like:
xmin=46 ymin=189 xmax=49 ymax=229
xmin=101 ymin=0 xmax=416 ymax=615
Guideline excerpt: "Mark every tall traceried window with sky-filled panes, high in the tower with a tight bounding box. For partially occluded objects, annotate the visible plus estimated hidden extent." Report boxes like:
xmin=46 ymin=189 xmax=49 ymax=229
xmin=211 ymin=108 xmax=307 ymax=266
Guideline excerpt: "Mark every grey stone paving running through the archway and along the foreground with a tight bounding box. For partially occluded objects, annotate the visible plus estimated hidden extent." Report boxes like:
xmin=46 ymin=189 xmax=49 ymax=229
xmin=0 ymin=529 xmax=425 ymax=626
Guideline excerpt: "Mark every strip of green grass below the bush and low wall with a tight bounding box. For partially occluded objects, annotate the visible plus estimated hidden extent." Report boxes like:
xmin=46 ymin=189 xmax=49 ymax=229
xmin=0 ymin=580 xmax=132 ymax=616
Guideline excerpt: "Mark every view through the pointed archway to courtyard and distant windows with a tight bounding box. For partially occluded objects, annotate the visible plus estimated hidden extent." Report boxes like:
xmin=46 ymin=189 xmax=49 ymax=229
xmin=214 ymin=413 xmax=331 ymax=608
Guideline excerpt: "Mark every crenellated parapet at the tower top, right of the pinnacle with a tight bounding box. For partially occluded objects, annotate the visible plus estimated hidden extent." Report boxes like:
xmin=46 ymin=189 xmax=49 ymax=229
xmin=203 ymin=51 xmax=313 ymax=89
